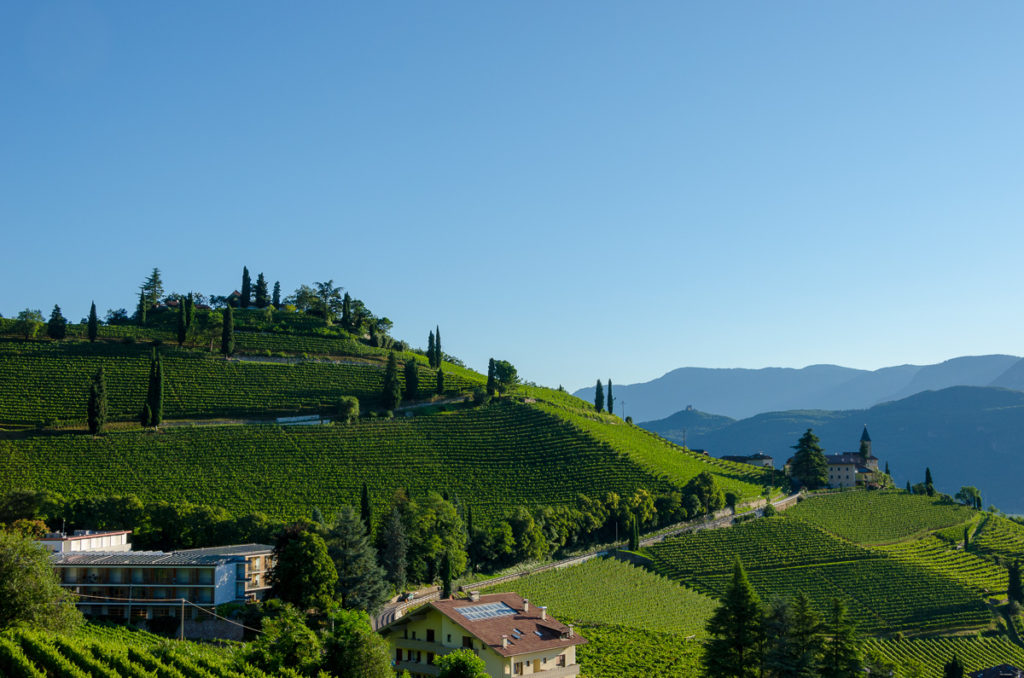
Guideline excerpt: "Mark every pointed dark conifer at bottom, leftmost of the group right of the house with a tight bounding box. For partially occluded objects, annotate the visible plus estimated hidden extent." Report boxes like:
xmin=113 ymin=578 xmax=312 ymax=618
xmin=702 ymin=558 xmax=761 ymax=678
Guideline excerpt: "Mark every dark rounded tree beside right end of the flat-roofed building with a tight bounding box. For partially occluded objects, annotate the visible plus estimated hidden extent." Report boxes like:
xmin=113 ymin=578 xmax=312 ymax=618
xmin=268 ymin=532 xmax=338 ymax=609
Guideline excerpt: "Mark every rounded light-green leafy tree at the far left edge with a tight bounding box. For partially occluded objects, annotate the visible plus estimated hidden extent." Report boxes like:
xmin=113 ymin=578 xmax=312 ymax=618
xmin=0 ymin=529 xmax=82 ymax=631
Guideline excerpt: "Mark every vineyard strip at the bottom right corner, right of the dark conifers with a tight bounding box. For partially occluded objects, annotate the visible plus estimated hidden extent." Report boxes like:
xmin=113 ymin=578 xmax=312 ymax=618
xmin=865 ymin=636 xmax=1024 ymax=676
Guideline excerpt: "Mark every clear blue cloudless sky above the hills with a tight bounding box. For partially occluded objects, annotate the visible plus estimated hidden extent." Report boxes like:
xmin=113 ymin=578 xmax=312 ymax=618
xmin=0 ymin=0 xmax=1024 ymax=389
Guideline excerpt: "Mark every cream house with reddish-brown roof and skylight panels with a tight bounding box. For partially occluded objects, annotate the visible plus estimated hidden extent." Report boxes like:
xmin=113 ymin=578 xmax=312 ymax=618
xmin=380 ymin=591 xmax=587 ymax=678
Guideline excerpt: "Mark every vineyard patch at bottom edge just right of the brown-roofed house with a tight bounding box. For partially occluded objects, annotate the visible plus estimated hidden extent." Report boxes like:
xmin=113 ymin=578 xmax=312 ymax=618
xmin=577 ymin=626 xmax=703 ymax=678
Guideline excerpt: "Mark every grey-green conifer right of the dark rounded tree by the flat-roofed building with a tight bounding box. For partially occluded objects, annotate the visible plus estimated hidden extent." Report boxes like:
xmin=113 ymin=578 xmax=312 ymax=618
xmin=327 ymin=506 xmax=387 ymax=612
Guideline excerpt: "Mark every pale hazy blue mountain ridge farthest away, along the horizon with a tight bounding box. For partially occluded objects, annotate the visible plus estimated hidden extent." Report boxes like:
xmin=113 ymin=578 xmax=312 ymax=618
xmin=574 ymin=354 xmax=1024 ymax=421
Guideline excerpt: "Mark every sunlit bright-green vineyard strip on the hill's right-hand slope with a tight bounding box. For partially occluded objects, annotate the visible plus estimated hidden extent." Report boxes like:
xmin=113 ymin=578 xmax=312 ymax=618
xmin=531 ymin=401 xmax=771 ymax=499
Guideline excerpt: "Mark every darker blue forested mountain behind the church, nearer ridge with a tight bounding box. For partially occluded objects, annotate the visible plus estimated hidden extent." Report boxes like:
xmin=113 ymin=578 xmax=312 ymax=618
xmin=641 ymin=386 xmax=1024 ymax=513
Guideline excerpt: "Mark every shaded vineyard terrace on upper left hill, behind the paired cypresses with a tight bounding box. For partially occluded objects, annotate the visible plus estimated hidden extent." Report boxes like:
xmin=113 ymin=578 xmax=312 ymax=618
xmin=0 ymin=341 xmax=476 ymax=424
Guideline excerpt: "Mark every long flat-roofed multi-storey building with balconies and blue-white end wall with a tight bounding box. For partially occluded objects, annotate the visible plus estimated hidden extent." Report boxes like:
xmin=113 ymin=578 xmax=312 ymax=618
xmin=39 ymin=531 xmax=273 ymax=635
